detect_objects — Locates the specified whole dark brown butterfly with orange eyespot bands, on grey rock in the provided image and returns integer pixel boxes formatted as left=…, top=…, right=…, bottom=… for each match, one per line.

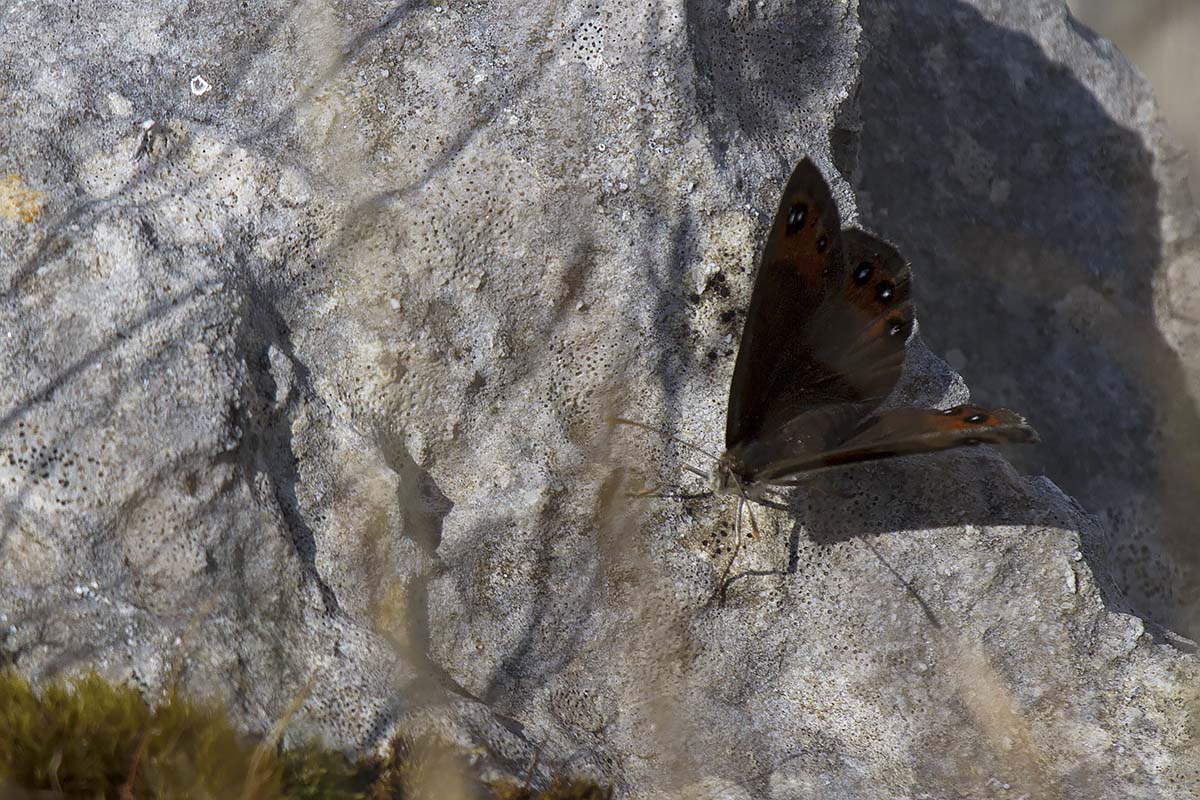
left=613, top=158, right=1038, bottom=524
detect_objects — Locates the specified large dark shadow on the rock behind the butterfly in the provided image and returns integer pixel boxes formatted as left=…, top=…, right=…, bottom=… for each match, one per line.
left=840, top=0, right=1200, bottom=634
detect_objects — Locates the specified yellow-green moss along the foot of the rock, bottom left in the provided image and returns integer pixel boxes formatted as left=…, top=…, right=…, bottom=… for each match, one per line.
left=0, top=669, right=612, bottom=800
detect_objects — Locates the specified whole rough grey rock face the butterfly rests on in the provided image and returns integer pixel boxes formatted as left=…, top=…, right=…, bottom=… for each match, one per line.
left=0, top=0, right=1200, bottom=798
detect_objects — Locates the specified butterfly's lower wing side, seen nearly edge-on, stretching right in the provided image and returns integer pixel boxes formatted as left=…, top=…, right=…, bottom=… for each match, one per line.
left=755, top=405, right=1038, bottom=485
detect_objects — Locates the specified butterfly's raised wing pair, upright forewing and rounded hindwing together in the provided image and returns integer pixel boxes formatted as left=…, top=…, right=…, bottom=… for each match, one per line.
left=725, top=158, right=913, bottom=453
